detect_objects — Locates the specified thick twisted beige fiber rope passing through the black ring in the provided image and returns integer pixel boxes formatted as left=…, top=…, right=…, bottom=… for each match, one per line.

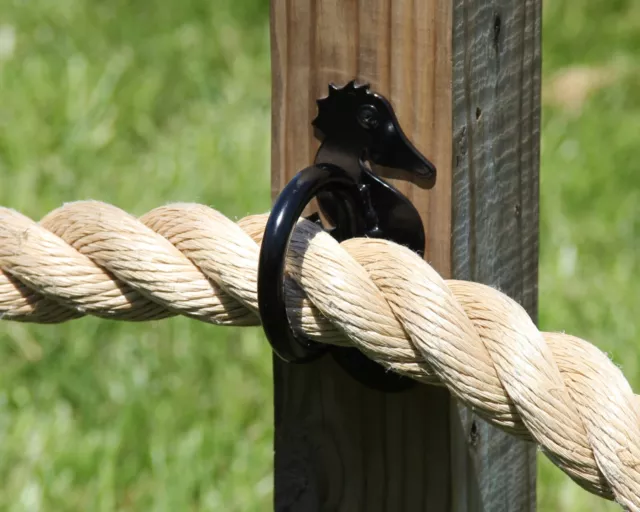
left=0, top=202, right=640, bottom=510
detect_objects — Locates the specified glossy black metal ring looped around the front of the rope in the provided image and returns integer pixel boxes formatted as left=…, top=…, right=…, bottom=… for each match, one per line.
left=258, top=164, right=363, bottom=363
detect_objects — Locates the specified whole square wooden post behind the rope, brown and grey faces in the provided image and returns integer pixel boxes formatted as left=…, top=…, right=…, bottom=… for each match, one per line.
left=271, top=0, right=541, bottom=512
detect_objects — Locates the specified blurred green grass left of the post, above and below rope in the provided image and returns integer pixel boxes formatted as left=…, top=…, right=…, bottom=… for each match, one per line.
left=0, top=0, right=273, bottom=512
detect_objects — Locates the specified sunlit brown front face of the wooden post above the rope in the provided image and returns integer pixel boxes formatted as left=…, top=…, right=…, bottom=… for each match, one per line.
left=271, top=0, right=452, bottom=266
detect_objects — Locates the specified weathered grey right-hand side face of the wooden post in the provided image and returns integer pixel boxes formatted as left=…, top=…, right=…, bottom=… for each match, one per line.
left=452, top=0, right=541, bottom=511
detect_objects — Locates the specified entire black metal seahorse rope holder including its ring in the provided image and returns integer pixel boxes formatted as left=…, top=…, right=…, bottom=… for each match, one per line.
left=258, top=82, right=436, bottom=391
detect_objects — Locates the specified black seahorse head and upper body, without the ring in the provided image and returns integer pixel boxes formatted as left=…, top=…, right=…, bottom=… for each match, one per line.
left=313, top=81, right=436, bottom=253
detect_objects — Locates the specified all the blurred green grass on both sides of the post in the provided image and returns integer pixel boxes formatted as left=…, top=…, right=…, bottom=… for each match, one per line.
left=0, top=0, right=640, bottom=512
